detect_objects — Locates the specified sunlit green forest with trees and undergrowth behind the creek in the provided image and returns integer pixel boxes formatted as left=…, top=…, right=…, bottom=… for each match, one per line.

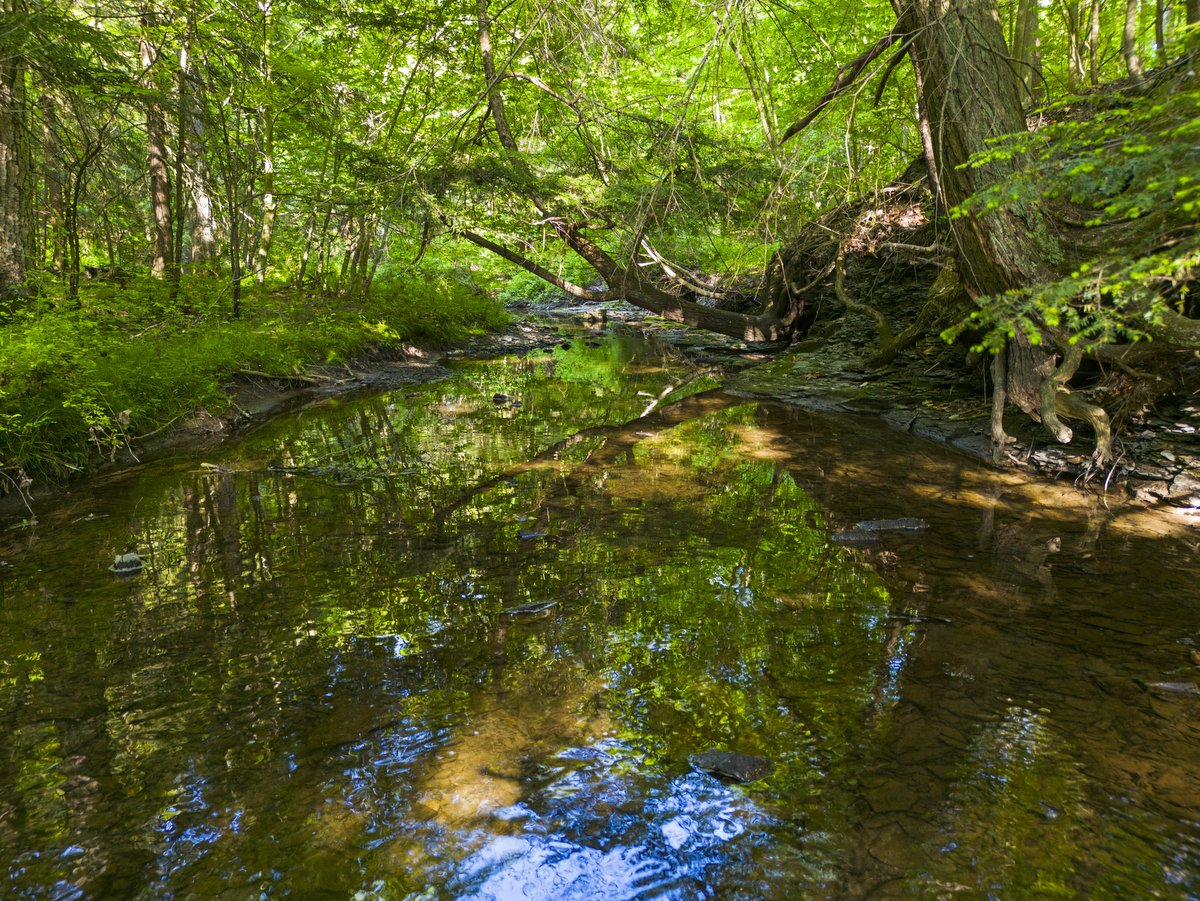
left=0, top=0, right=1200, bottom=488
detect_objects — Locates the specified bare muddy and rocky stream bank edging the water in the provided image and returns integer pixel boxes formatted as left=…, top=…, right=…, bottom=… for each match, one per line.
left=0, top=301, right=1200, bottom=521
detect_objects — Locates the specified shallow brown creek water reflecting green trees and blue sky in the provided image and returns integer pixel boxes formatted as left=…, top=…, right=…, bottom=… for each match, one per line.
left=0, top=334, right=1200, bottom=900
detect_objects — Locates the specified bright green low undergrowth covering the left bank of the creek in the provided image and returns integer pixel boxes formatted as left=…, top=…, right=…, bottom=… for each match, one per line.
left=0, top=278, right=508, bottom=493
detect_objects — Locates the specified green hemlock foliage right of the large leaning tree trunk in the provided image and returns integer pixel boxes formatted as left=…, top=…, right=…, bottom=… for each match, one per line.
left=948, top=62, right=1200, bottom=349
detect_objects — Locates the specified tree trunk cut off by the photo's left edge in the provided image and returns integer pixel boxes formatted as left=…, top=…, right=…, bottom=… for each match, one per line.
left=0, top=0, right=30, bottom=302
